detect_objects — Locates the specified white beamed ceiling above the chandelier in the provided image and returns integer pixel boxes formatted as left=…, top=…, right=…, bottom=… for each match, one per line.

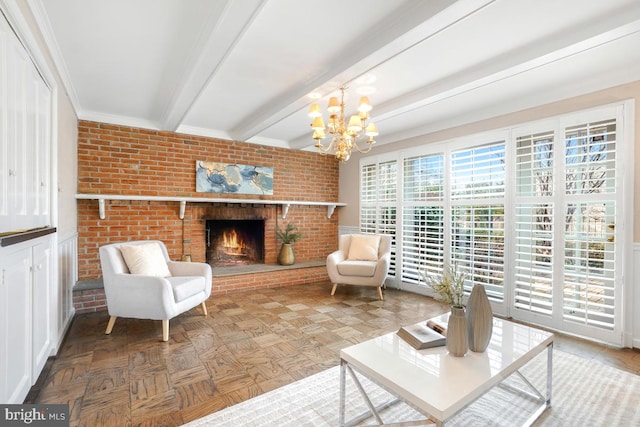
left=28, top=0, right=640, bottom=149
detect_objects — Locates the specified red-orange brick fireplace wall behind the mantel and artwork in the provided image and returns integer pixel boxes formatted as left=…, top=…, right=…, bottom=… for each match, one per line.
left=78, top=121, right=339, bottom=310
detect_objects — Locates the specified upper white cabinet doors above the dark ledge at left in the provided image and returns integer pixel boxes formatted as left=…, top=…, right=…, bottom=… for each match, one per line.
left=0, top=10, right=52, bottom=236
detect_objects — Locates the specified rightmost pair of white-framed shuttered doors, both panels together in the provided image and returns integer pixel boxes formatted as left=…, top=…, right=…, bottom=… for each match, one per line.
left=511, top=107, right=631, bottom=344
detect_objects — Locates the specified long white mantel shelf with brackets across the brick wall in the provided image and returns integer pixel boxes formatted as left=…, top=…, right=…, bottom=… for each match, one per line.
left=76, top=194, right=346, bottom=219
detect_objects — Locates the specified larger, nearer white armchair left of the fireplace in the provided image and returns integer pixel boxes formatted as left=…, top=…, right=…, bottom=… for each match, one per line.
left=100, top=240, right=212, bottom=341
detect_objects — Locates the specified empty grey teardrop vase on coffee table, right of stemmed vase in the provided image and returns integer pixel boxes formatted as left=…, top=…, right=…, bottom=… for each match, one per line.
left=467, top=285, right=493, bottom=352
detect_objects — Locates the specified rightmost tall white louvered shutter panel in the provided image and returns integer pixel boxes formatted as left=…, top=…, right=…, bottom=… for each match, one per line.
left=563, top=119, right=616, bottom=330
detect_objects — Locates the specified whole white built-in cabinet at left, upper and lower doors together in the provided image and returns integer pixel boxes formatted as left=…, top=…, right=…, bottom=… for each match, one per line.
left=0, top=8, right=60, bottom=404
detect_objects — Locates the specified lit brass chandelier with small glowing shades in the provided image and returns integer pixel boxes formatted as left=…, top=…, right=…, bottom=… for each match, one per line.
left=309, top=86, right=378, bottom=163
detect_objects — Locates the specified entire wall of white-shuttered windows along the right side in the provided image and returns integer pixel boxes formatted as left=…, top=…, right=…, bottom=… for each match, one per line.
left=360, top=103, right=633, bottom=344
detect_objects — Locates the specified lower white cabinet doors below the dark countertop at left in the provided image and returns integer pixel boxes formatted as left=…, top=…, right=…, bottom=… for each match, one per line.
left=0, top=237, right=52, bottom=403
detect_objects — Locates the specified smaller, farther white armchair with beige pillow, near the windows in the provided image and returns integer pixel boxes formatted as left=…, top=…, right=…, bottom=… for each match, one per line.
left=327, top=234, right=391, bottom=300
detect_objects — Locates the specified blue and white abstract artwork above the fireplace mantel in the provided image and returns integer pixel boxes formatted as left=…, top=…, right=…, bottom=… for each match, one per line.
left=196, top=160, right=273, bottom=196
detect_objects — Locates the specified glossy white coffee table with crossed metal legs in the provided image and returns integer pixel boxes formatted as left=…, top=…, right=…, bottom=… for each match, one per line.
left=339, top=318, right=553, bottom=426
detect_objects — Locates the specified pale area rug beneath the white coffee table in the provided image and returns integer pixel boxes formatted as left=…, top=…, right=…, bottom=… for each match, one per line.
left=185, top=350, right=640, bottom=427
